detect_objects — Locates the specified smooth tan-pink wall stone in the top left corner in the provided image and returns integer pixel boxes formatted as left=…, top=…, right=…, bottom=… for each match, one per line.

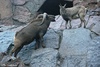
left=0, top=0, right=12, bottom=19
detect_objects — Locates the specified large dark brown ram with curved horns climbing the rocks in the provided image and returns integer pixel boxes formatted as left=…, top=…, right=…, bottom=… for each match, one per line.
left=10, top=13, right=55, bottom=57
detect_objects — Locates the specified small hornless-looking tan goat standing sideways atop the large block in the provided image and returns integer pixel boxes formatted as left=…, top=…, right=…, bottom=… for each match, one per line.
left=59, top=4, right=87, bottom=29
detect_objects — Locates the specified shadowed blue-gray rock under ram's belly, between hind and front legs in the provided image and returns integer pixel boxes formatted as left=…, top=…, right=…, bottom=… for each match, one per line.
left=18, top=41, right=36, bottom=65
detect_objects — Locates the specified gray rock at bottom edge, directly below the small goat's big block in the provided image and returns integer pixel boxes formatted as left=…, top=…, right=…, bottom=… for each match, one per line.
left=60, top=55, right=86, bottom=67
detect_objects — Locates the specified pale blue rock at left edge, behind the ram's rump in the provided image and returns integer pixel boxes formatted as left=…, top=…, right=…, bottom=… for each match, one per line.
left=0, top=31, right=15, bottom=52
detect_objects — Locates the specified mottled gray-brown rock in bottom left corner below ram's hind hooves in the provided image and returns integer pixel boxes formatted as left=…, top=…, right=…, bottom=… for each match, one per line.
left=0, top=55, right=26, bottom=67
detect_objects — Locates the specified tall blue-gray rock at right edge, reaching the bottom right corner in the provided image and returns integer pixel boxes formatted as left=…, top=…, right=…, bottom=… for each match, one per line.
left=87, top=36, right=100, bottom=67
